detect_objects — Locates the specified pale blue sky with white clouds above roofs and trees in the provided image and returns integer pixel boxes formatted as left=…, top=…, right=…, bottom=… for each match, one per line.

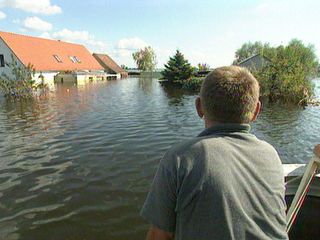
left=0, top=0, right=320, bottom=68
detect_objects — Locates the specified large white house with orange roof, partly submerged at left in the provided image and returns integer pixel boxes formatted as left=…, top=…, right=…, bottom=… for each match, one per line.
left=0, top=32, right=107, bottom=84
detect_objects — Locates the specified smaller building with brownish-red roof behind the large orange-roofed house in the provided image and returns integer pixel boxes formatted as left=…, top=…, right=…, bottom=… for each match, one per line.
left=93, top=53, right=128, bottom=79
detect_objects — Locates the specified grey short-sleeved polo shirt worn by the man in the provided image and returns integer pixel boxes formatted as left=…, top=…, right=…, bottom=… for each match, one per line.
left=141, top=124, right=288, bottom=240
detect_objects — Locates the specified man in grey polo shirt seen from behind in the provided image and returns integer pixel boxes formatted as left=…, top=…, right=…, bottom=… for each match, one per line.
left=141, top=66, right=288, bottom=240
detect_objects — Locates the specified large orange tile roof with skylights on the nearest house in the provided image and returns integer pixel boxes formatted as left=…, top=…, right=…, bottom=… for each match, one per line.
left=0, top=31, right=103, bottom=71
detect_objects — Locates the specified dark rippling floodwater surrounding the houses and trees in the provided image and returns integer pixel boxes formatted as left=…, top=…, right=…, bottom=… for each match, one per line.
left=0, top=79, right=320, bottom=240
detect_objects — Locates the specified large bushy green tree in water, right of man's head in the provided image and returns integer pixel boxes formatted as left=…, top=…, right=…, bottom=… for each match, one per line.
left=239, top=39, right=319, bottom=103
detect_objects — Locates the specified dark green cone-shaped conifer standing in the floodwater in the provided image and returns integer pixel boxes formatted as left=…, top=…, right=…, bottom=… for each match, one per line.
left=162, top=50, right=193, bottom=82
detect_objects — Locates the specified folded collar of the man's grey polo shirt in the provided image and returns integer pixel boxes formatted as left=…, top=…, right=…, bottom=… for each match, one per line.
left=198, top=123, right=251, bottom=137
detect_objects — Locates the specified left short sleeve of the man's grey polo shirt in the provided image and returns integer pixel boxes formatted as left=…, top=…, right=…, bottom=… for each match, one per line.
left=140, top=153, right=176, bottom=233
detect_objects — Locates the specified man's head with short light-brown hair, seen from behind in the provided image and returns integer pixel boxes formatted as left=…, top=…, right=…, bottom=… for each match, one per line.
left=196, top=66, right=261, bottom=123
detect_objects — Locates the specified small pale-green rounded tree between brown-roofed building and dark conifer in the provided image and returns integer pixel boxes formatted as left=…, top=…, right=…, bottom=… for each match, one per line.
left=132, top=46, right=157, bottom=71
